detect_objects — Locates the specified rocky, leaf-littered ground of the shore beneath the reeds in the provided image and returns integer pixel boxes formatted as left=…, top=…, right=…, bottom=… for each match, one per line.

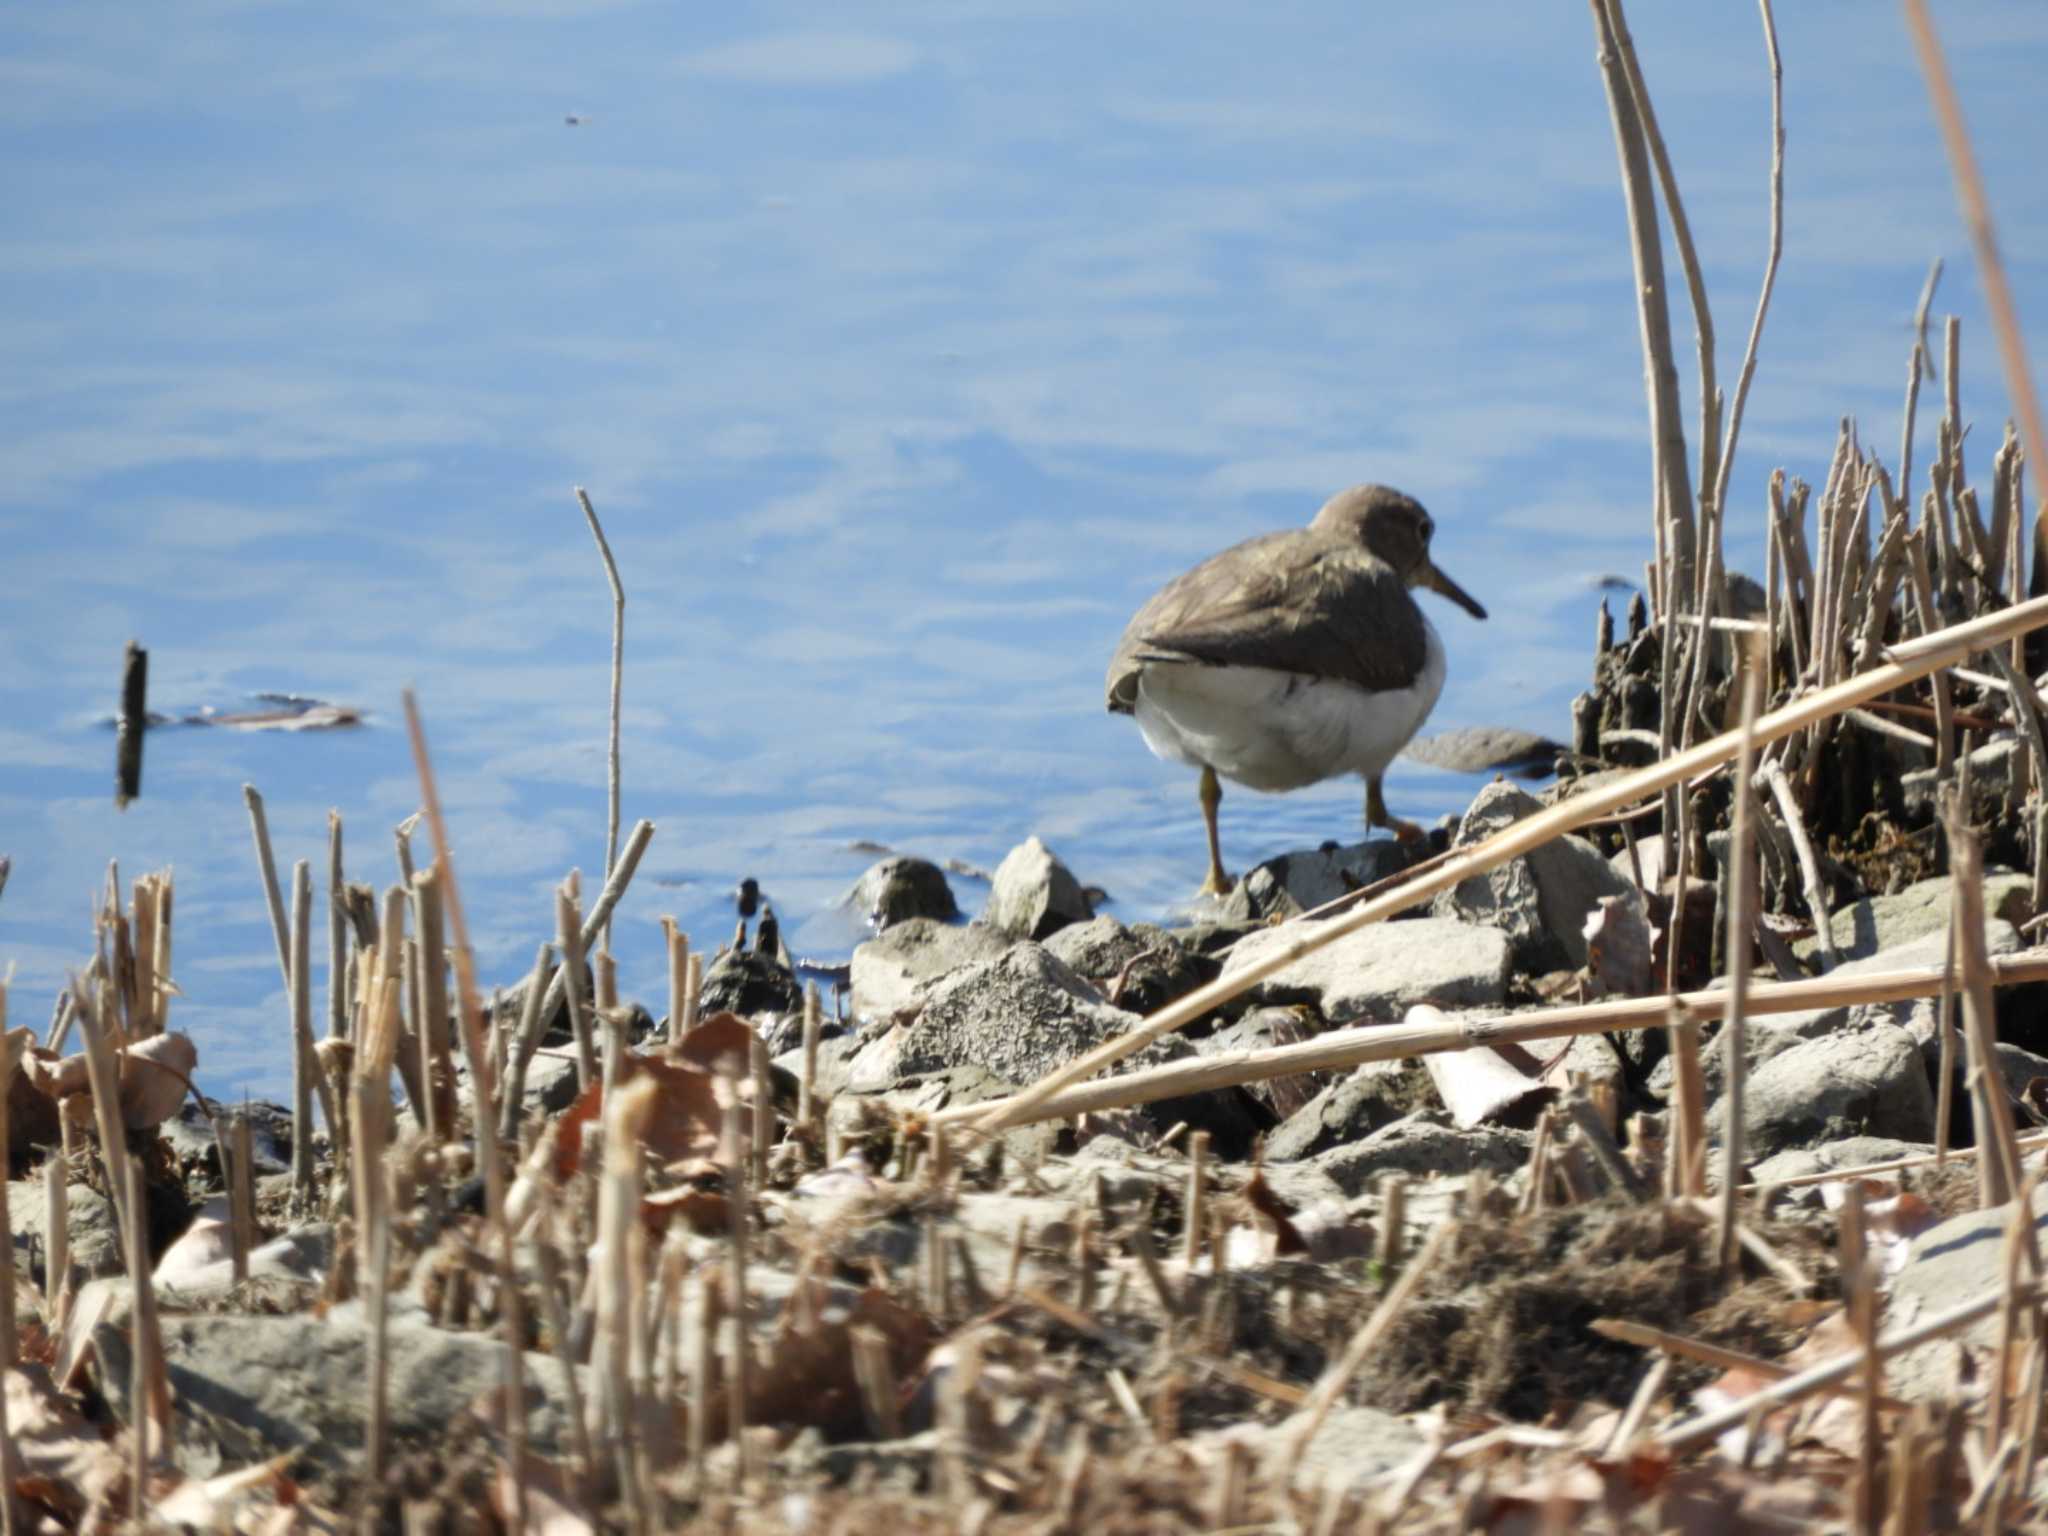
left=8, top=761, right=2048, bottom=1530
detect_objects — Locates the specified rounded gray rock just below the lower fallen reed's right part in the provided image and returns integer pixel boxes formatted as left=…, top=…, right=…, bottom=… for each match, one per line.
left=1710, top=1024, right=1933, bottom=1159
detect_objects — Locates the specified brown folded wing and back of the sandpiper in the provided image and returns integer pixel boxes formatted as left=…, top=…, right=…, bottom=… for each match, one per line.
left=1108, top=530, right=1427, bottom=713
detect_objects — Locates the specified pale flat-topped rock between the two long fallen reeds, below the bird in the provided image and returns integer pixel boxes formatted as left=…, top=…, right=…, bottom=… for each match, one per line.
left=1223, top=918, right=1511, bottom=1024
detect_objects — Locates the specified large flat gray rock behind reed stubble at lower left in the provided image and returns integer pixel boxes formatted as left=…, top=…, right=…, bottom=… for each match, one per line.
left=92, top=1313, right=590, bottom=1477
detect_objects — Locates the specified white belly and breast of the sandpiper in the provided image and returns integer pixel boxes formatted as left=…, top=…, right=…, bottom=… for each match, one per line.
left=1135, top=627, right=1444, bottom=791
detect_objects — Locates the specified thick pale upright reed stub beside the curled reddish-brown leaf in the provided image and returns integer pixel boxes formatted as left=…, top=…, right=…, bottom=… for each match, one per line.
left=592, top=1075, right=655, bottom=1530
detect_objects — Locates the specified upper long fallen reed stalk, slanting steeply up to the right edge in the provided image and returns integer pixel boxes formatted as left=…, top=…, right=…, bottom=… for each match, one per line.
left=966, top=598, right=2048, bottom=1130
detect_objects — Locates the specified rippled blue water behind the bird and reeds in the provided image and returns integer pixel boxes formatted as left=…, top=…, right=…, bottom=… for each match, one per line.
left=0, top=0, right=2048, bottom=1096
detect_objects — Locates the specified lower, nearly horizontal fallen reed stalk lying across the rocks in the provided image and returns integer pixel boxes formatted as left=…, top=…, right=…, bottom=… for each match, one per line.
left=950, top=952, right=2048, bottom=1124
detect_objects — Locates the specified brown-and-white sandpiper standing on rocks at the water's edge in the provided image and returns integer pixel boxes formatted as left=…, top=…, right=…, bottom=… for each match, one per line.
left=1106, top=485, right=1487, bottom=895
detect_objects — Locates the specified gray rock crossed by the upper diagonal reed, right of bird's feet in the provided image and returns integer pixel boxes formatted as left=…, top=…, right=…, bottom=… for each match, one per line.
left=1432, top=782, right=1640, bottom=973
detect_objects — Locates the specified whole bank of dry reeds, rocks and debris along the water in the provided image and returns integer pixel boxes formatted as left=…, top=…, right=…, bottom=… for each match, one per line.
left=0, top=0, right=2048, bottom=1536
